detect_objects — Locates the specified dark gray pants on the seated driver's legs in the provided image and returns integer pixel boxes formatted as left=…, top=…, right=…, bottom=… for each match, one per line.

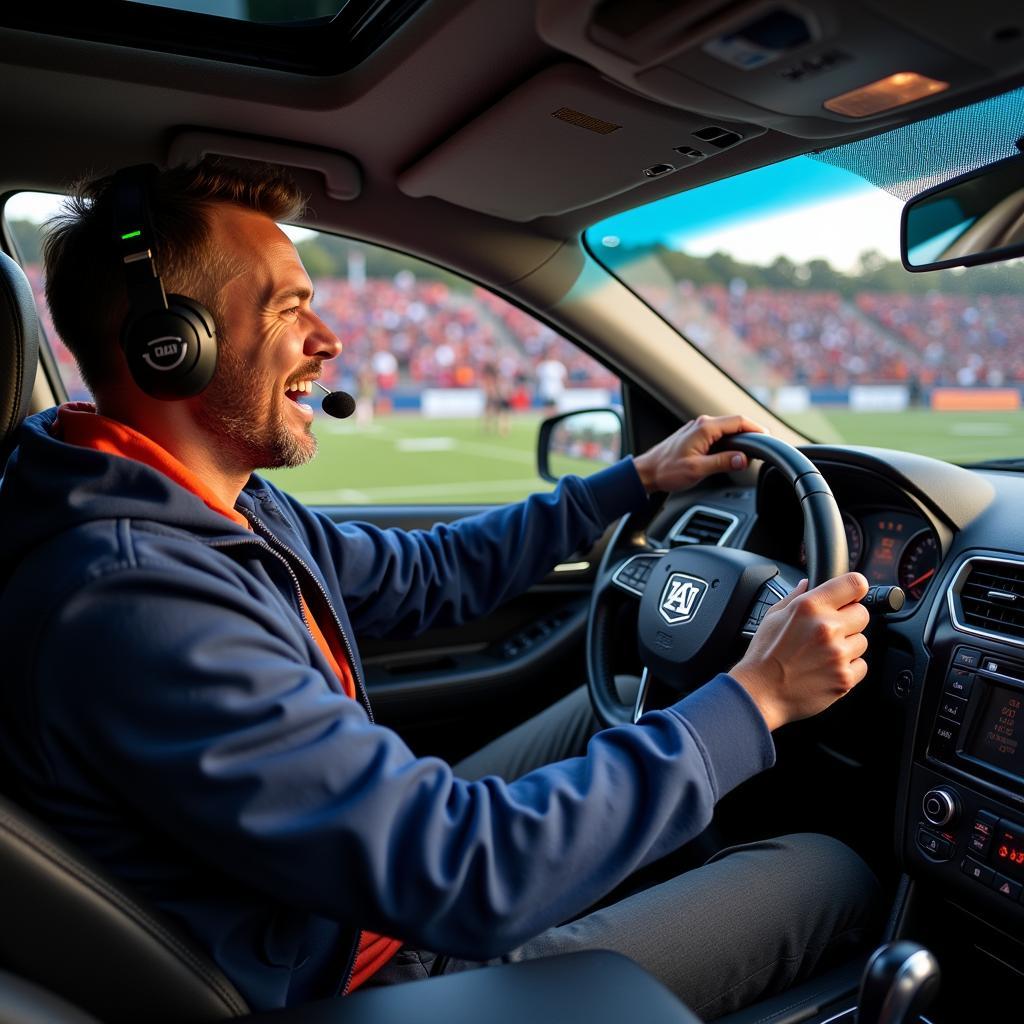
left=367, top=689, right=879, bottom=1020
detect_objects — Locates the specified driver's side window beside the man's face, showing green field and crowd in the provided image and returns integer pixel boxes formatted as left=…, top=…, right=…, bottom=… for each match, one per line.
left=5, top=193, right=620, bottom=505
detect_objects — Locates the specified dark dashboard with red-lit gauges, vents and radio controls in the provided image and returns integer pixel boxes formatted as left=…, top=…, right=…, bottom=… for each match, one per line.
left=651, top=445, right=1024, bottom=1003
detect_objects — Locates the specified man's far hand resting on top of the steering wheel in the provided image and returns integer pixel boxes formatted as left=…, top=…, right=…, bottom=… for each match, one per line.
left=634, top=416, right=766, bottom=494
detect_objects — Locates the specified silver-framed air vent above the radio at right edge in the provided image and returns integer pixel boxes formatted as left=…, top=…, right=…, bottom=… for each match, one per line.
left=949, top=558, right=1024, bottom=646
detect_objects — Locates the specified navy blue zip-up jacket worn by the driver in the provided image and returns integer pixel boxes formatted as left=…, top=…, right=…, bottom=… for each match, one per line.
left=0, top=410, right=774, bottom=1010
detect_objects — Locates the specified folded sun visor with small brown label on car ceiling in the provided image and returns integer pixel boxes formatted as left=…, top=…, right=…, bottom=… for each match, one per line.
left=398, top=65, right=765, bottom=221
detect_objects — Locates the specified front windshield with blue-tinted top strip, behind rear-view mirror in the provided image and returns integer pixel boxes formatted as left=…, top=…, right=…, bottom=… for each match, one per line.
left=586, top=90, right=1024, bottom=463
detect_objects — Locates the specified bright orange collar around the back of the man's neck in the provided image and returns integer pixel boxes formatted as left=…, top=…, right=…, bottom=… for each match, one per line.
left=53, top=401, right=251, bottom=529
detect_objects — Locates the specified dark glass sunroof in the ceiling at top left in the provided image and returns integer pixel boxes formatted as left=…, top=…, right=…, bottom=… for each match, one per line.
left=0, top=0, right=429, bottom=75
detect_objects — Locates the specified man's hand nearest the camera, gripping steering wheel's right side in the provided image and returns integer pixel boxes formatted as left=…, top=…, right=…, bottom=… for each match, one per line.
left=732, top=572, right=869, bottom=729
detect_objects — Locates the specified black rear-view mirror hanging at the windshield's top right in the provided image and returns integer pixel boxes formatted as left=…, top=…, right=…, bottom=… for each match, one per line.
left=900, top=155, right=1024, bottom=271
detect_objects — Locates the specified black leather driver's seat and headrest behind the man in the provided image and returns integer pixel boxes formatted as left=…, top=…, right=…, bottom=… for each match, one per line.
left=0, top=253, right=249, bottom=1022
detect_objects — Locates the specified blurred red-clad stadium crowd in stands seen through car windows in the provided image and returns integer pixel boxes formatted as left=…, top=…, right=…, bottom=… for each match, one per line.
left=19, top=264, right=1024, bottom=410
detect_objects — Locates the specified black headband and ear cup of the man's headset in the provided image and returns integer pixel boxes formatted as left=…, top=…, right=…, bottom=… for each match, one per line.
left=113, top=164, right=217, bottom=401
